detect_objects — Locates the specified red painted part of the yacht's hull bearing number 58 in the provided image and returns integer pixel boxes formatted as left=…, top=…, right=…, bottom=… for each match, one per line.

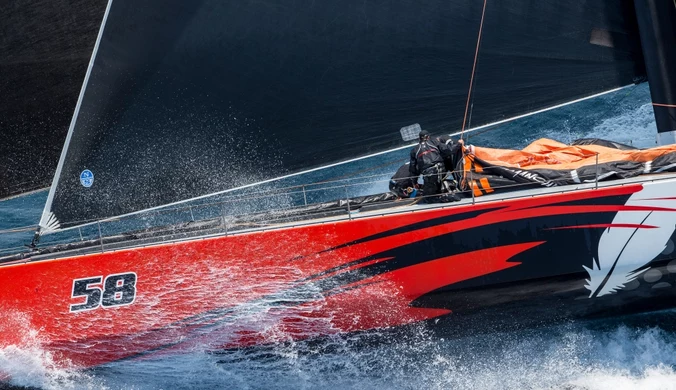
left=0, top=180, right=673, bottom=367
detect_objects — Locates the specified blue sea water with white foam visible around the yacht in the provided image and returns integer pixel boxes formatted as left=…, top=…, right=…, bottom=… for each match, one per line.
left=0, top=85, right=676, bottom=390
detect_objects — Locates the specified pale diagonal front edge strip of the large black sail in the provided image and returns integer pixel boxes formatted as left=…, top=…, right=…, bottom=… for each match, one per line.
left=38, top=0, right=113, bottom=234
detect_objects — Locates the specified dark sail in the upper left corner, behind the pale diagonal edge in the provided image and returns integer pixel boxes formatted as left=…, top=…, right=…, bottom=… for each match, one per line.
left=0, top=0, right=107, bottom=199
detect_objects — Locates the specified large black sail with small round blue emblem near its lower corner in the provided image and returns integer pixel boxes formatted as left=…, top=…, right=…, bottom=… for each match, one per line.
left=40, top=0, right=645, bottom=232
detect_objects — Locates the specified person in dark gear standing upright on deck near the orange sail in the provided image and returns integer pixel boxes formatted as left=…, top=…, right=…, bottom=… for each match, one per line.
left=409, top=130, right=451, bottom=203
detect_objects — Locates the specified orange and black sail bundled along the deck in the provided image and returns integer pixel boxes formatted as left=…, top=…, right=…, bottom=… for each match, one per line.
left=456, top=138, right=676, bottom=196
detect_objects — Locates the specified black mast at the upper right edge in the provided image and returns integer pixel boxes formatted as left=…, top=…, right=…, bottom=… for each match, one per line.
left=634, top=0, right=676, bottom=145
